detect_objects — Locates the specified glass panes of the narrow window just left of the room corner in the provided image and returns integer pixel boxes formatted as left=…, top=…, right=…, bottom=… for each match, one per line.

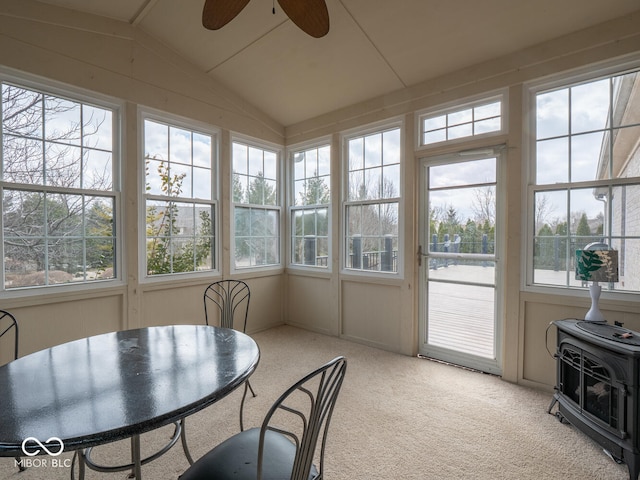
left=231, top=142, right=280, bottom=269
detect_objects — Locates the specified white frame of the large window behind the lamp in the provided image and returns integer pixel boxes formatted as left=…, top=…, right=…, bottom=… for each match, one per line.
left=521, top=57, right=640, bottom=300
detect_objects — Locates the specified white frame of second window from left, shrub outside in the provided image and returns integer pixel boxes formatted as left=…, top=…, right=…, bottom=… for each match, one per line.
left=137, top=106, right=222, bottom=283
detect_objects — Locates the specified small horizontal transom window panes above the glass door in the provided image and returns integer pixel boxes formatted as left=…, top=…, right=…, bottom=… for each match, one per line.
left=420, top=98, right=503, bottom=146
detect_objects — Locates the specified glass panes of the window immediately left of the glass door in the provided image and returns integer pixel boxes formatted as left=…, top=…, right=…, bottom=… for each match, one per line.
left=344, top=128, right=401, bottom=273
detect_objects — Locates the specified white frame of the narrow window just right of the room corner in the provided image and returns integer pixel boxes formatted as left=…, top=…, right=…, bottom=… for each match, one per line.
left=286, top=137, right=335, bottom=273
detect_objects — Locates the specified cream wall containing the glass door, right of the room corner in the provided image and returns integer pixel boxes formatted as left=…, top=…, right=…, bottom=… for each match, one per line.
left=286, top=11, right=640, bottom=390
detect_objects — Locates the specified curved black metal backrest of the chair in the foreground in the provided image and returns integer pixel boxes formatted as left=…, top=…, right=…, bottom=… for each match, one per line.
left=258, top=356, right=347, bottom=480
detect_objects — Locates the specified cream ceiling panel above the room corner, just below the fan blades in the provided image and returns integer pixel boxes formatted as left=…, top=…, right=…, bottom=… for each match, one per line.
left=211, top=0, right=403, bottom=125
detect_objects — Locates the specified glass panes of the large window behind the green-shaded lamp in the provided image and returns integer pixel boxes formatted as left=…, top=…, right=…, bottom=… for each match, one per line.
left=529, top=67, right=640, bottom=292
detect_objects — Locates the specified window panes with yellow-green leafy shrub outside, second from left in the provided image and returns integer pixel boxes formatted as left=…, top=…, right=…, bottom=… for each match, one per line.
left=143, top=115, right=217, bottom=276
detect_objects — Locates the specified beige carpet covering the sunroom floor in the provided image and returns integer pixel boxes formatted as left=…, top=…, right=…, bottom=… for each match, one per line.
left=0, top=327, right=628, bottom=480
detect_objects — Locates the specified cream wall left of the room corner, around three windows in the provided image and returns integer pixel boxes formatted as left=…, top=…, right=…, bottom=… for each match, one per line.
left=0, top=0, right=284, bottom=361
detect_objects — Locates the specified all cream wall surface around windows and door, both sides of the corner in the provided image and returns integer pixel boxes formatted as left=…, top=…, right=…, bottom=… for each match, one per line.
left=0, top=0, right=640, bottom=388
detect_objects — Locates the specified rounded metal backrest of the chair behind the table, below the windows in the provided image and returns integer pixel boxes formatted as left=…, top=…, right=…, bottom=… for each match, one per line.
left=204, top=280, right=251, bottom=332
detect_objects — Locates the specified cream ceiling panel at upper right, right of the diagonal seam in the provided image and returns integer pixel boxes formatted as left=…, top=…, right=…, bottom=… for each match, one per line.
left=344, top=0, right=640, bottom=86
